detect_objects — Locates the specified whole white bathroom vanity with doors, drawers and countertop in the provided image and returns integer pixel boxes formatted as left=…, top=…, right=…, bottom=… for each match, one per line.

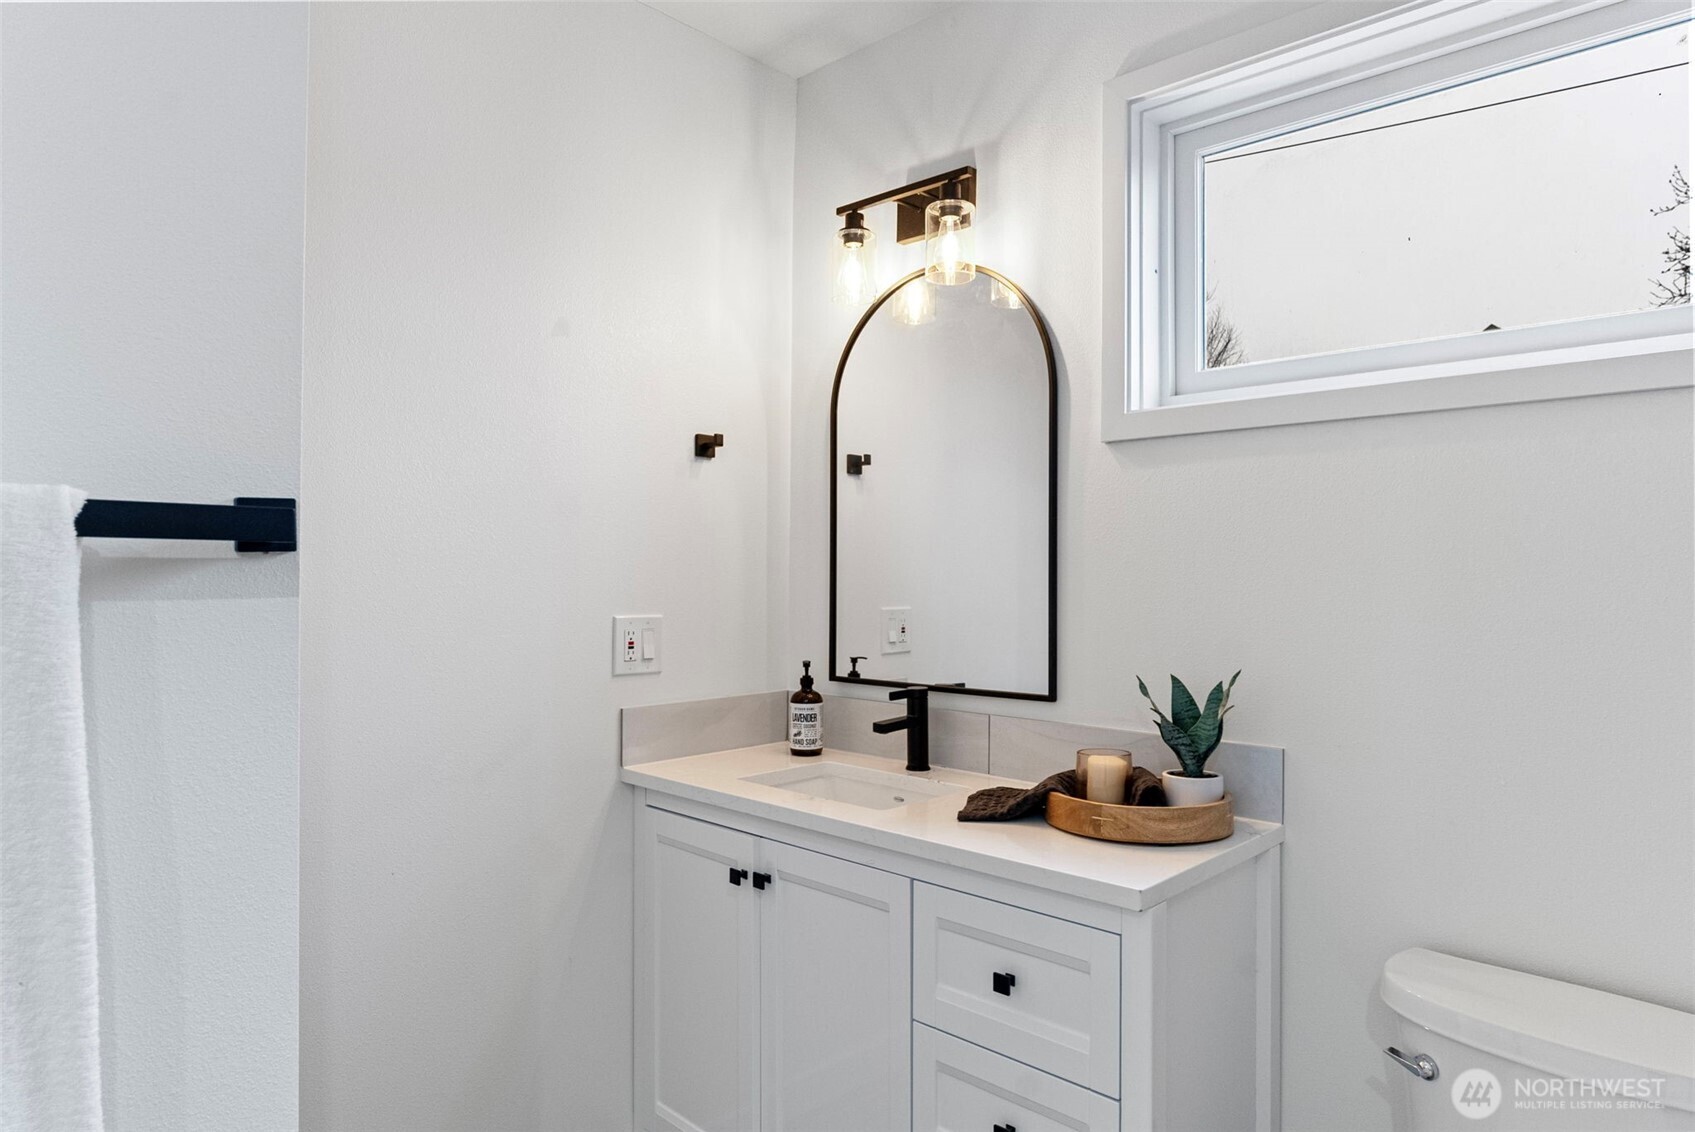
left=625, top=749, right=1281, bottom=1132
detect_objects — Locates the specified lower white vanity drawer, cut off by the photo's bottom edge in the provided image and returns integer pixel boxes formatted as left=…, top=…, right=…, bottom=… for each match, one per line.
left=912, top=1022, right=1119, bottom=1132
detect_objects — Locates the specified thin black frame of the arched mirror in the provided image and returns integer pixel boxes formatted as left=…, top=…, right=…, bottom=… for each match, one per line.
left=829, top=264, right=1059, bottom=702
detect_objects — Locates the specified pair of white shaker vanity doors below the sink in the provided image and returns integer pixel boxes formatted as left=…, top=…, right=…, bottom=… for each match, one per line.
left=636, top=808, right=912, bottom=1132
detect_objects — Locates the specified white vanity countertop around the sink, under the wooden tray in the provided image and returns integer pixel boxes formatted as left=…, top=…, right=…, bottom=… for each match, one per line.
left=622, top=742, right=1283, bottom=910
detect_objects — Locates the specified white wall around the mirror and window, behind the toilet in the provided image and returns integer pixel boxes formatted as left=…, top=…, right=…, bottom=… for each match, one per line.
left=790, top=3, right=1695, bottom=1132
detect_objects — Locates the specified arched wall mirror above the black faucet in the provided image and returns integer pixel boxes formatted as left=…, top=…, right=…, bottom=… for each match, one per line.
left=831, top=266, right=1059, bottom=700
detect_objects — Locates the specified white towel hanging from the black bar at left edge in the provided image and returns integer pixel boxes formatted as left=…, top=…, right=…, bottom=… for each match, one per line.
left=0, top=483, right=102, bottom=1132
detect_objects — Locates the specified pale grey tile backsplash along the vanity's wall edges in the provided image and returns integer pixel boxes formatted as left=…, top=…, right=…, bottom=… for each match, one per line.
left=620, top=691, right=1283, bottom=822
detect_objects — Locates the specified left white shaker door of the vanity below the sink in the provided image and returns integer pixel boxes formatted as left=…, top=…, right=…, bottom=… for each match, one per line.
left=636, top=808, right=761, bottom=1132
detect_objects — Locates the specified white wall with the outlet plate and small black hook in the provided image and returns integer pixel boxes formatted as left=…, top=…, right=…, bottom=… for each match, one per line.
left=302, top=3, right=796, bottom=1132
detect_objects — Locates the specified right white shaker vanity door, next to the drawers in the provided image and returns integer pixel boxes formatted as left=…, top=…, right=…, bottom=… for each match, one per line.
left=758, top=841, right=908, bottom=1132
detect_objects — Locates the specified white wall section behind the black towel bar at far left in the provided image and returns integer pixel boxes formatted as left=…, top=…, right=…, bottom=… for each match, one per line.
left=0, top=3, right=307, bottom=1132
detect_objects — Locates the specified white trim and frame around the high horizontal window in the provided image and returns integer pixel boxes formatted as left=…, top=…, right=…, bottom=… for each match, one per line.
left=1102, top=0, right=1695, bottom=441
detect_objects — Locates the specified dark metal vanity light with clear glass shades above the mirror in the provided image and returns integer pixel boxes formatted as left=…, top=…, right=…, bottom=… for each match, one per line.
left=834, top=164, right=976, bottom=306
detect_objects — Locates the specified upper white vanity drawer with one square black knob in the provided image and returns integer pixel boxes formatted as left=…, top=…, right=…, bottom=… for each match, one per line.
left=912, top=881, right=1120, bottom=1096
